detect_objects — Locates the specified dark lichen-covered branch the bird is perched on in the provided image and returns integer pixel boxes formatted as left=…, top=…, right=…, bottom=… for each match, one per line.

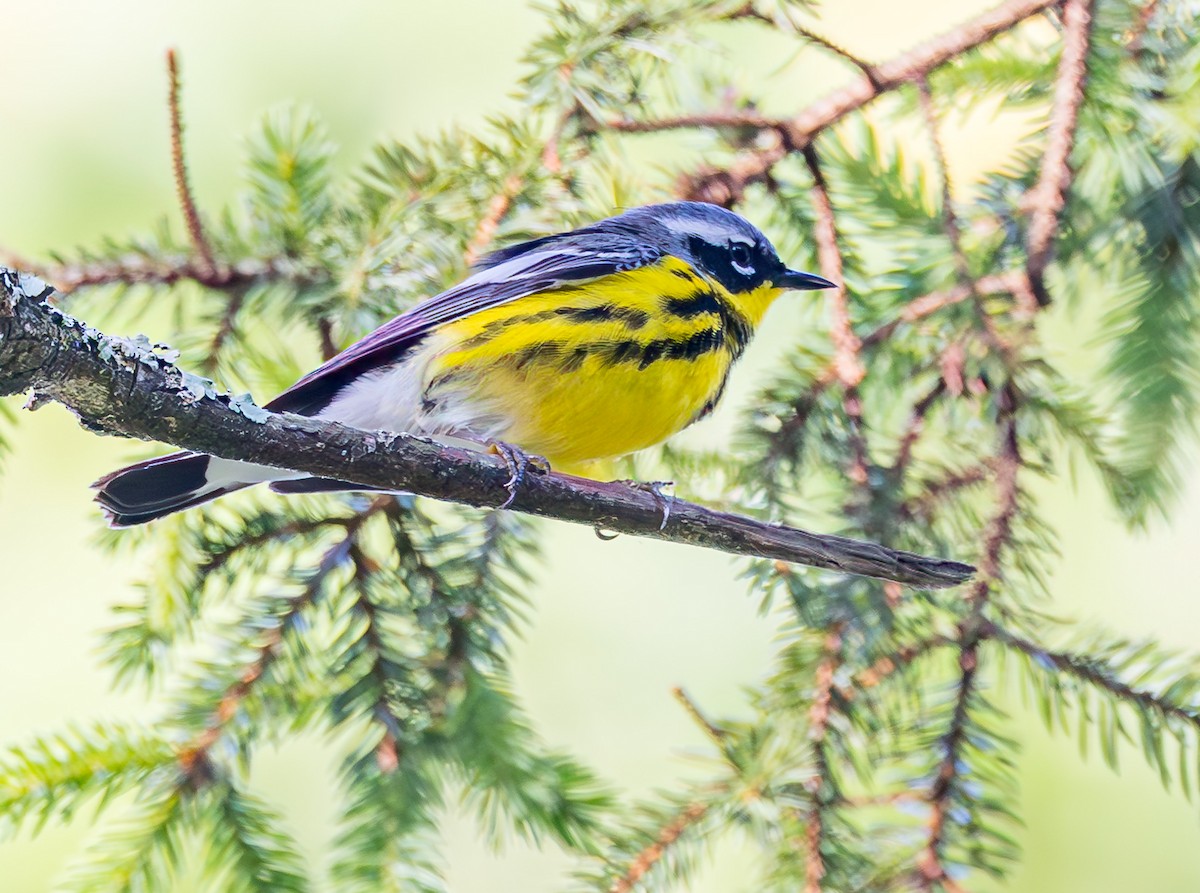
left=0, top=271, right=974, bottom=588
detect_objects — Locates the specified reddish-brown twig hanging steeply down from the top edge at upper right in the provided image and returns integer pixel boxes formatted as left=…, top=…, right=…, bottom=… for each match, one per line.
left=1026, top=0, right=1093, bottom=306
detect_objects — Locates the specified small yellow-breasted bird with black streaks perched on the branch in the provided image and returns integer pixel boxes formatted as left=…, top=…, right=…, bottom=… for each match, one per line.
left=92, top=202, right=835, bottom=527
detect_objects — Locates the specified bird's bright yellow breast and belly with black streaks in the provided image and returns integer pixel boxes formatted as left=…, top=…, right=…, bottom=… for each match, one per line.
left=424, top=258, right=780, bottom=468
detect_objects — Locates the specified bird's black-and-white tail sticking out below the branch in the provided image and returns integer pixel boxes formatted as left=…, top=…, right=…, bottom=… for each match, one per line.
left=92, top=453, right=278, bottom=527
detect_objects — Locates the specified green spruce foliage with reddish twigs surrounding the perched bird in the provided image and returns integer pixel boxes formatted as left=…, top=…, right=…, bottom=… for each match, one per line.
left=0, top=0, right=1200, bottom=893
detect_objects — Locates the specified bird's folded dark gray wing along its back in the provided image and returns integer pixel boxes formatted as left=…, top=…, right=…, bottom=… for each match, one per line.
left=266, top=234, right=661, bottom=415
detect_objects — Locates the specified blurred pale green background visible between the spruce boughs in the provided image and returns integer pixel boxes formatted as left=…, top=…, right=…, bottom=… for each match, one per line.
left=0, top=0, right=1200, bottom=893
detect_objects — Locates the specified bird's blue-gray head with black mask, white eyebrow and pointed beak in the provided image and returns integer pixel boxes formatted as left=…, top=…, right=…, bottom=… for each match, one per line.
left=588, top=202, right=835, bottom=294
